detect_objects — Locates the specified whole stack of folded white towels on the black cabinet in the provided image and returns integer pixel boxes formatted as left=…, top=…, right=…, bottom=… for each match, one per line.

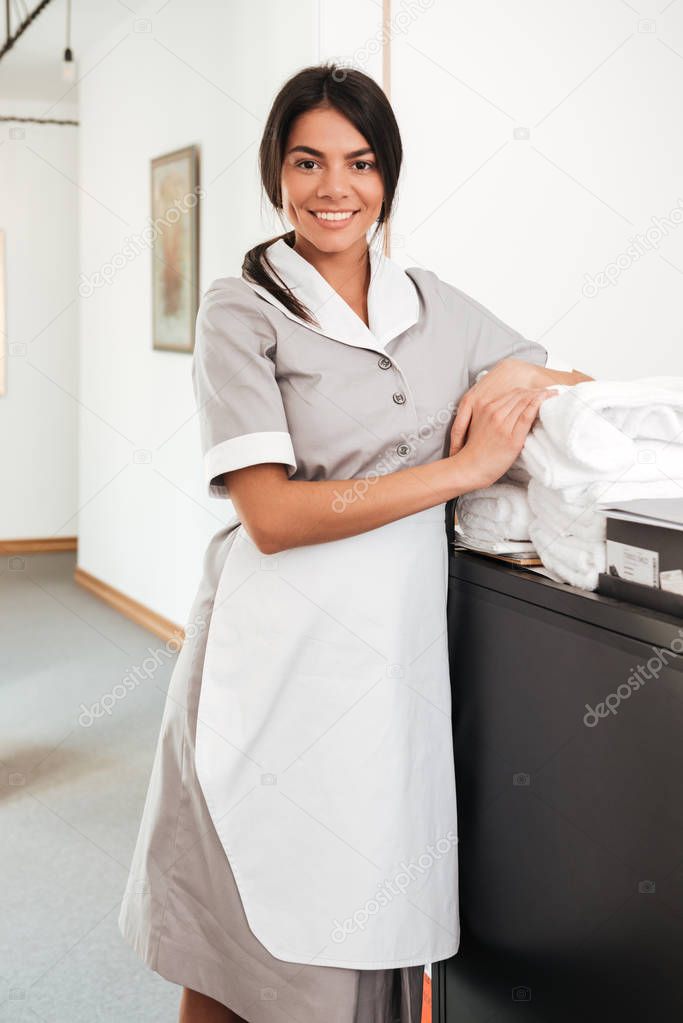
left=456, top=376, right=683, bottom=589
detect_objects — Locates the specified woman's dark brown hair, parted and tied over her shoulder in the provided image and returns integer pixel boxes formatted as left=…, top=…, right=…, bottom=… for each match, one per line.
left=242, top=62, right=403, bottom=326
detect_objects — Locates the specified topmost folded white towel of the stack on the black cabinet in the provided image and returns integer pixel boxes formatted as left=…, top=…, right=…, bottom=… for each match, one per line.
left=515, top=376, right=683, bottom=494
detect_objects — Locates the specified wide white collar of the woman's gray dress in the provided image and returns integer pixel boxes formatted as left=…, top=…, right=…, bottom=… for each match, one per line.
left=243, top=238, right=419, bottom=349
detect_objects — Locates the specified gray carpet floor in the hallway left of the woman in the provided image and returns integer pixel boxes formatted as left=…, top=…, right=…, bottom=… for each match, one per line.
left=0, top=551, right=180, bottom=1023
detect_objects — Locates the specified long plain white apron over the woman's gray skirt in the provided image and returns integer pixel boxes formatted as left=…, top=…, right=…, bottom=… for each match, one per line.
left=195, top=504, right=459, bottom=969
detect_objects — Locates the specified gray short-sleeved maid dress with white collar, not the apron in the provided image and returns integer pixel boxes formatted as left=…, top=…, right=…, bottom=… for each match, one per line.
left=119, top=242, right=547, bottom=1023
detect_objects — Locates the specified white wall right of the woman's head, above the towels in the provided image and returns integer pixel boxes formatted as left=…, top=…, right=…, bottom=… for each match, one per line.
left=392, top=0, right=683, bottom=380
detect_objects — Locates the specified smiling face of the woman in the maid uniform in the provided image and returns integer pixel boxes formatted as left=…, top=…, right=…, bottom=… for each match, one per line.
left=281, top=108, right=384, bottom=253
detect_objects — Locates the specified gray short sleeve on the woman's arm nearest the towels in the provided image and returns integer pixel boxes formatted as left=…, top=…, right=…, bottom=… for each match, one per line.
left=441, top=281, right=548, bottom=387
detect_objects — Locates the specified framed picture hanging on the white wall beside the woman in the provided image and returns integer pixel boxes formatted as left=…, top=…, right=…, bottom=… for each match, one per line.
left=151, top=145, right=199, bottom=352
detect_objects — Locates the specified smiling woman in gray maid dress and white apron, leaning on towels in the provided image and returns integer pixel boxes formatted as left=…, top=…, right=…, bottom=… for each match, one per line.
left=120, top=64, right=582, bottom=1023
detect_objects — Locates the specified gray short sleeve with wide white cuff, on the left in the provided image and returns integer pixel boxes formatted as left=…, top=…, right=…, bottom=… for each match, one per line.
left=192, top=277, right=297, bottom=498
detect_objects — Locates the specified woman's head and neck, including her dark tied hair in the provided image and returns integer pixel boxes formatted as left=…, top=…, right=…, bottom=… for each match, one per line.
left=242, top=65, right=403, bottom=324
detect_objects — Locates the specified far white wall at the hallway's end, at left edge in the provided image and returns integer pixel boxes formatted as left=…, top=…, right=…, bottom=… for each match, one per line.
left=0, top=99, right=78, bottom=540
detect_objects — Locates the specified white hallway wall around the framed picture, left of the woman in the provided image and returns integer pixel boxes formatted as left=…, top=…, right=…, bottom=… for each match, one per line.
left=79, top=0, right=315, bottom=623
